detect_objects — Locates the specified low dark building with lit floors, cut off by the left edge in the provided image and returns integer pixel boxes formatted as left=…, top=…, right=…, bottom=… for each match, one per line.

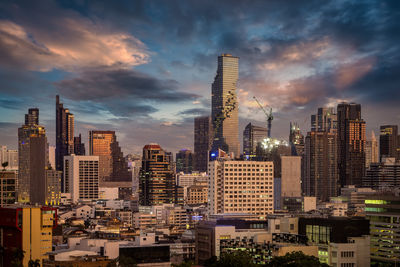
left=0, top=170, right=18, bottom=207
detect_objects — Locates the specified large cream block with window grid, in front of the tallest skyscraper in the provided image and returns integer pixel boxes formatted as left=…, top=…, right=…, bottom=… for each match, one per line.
left=208, top=159, right=274, bottom=218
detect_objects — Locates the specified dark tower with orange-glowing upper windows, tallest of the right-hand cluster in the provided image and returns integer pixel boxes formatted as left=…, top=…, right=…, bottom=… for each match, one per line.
left=337, top=103, right=366, bottom=187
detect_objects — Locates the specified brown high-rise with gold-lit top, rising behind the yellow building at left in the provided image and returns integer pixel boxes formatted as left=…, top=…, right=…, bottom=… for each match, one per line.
left=18, top=109, right=48, bottom=204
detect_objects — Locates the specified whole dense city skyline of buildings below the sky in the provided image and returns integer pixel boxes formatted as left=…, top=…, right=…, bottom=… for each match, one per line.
left=0, top=54, right=400, bottom=267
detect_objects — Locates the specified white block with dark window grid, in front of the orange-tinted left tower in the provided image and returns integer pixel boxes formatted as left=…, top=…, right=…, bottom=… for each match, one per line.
left=64, top=154, right=100, bottom=203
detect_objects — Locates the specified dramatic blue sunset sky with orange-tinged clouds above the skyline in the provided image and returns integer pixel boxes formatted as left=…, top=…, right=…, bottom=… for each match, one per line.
left=0, top=0, right=400, bottom=153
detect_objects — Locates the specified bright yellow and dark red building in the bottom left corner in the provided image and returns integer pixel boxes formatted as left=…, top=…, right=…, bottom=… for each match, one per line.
left=0, top=207, right=57, bottom=266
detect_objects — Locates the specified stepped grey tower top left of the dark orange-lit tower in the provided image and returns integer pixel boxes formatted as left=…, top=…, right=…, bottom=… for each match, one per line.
left=311, top=108, right=337, bottom=132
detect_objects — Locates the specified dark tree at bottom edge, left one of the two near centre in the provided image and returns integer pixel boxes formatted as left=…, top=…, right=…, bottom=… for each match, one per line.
left=204, top=251, right=257, bottom=267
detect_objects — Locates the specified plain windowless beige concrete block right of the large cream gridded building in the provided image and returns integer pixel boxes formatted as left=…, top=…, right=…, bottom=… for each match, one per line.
left=281, top=156, right=301, bottom=197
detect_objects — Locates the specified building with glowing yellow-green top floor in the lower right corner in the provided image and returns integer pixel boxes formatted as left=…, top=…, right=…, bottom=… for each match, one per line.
left=365, top=192, right=400, bottom=266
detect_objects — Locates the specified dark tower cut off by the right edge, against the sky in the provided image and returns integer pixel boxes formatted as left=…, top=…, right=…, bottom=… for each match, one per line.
left=379, top=125, right=398, bottom=160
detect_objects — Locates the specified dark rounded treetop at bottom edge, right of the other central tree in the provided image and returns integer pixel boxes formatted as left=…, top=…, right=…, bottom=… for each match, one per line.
left=265, top=251, right=329, bottom=267
